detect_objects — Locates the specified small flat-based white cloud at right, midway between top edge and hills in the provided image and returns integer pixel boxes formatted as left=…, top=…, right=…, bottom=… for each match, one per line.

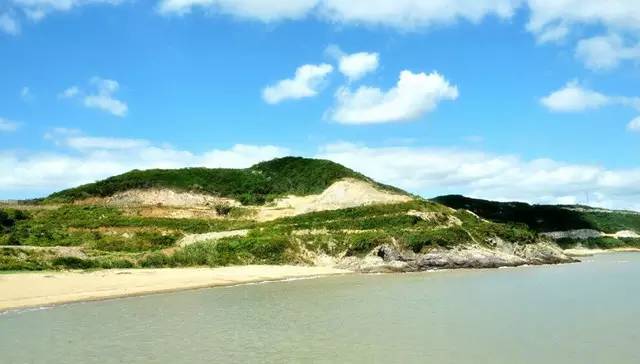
left=540, top=81, right=612, bottom=112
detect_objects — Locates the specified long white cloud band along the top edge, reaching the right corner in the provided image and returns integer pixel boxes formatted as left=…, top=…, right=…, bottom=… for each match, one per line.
left=154, top=0, right=640, bottom=41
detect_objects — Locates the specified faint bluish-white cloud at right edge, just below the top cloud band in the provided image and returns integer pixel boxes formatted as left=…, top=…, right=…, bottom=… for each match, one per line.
left=576, top=34, right=640, bottom=70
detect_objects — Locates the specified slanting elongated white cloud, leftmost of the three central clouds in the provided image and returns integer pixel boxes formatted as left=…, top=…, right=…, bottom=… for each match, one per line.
left=262, top=64, right=333, bottom=104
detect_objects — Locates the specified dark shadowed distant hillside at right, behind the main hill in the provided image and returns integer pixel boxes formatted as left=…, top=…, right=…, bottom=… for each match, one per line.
left=433, top=195, right=640, bottom=233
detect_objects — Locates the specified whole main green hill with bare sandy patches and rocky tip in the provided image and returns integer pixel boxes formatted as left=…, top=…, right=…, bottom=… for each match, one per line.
left=0, top=157, right=572, bottom=272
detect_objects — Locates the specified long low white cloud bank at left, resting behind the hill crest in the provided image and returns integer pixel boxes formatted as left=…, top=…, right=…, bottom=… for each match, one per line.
left=0, top=129, right=288, bottom=198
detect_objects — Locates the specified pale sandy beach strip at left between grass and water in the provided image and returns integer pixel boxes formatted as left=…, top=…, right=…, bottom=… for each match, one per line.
left=0, top=265, right=350, bottom=311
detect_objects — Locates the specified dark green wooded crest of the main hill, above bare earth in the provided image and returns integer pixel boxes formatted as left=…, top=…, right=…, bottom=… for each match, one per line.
left=47, top=157, right=400, bottom=205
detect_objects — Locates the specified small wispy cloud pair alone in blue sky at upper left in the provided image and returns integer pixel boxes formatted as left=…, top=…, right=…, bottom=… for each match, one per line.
left=58, top=77, right=129, bottom=117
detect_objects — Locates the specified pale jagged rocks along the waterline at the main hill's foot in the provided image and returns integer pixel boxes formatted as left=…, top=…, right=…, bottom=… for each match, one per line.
left=334, top=240, right=576, bottom=273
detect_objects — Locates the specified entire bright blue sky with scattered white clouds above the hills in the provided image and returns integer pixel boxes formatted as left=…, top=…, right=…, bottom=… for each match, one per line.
left=0, top=0, right=640, bottom=210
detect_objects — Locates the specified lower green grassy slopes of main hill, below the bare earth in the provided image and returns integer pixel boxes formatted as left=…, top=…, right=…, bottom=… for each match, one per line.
left=0, top=200, right=536, bottom=270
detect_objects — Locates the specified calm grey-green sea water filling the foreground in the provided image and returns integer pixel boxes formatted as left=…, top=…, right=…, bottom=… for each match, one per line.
left=0, top=253, right=640, bottom=364
